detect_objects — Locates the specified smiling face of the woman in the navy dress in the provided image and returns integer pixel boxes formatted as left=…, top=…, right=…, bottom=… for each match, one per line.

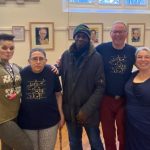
left=135, top=50, right=150, bottom=70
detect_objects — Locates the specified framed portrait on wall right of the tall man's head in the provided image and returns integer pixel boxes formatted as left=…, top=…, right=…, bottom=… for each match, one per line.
left=127, top=23, right=145, bottom=47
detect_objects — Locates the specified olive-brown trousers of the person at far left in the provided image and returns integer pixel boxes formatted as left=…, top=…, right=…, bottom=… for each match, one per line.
left=0, top=121, right=34, bottom=150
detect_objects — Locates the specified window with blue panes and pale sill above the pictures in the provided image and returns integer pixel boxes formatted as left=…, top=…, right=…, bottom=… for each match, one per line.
left=63, top=0, right=150, bottom=14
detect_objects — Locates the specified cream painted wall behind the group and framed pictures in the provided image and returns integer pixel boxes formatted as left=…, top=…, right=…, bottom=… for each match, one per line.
left=0, top=0, right=150, bottom=66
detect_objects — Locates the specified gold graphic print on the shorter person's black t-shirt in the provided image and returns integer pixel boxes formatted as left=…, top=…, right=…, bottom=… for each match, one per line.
left=27, top=79, right=46, bottom=100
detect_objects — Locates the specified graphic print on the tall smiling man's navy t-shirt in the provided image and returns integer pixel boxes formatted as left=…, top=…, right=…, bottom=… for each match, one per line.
left=109, top=55, right=127, bottom=74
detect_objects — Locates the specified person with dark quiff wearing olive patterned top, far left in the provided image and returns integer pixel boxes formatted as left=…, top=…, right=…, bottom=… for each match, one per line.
left=0, top=33, right=33, bottom=150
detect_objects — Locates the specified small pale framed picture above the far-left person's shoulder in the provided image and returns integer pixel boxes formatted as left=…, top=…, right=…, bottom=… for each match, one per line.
left=12, top=26, right=25, bottom=41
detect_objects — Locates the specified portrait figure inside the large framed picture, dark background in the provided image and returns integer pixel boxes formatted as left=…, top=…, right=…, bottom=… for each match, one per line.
left=36, top=27, right=49, bottom=45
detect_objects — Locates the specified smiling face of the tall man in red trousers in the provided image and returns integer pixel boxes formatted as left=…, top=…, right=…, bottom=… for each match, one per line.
left=110, top=23, right=128, bottom=47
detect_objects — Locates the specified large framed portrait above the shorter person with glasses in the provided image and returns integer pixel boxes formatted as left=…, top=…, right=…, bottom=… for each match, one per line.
left=29, top=22, right=54, bottom=50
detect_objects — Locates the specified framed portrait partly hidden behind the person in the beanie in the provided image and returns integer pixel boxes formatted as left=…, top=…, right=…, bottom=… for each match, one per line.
left=86, top=23, right=103, bottom=46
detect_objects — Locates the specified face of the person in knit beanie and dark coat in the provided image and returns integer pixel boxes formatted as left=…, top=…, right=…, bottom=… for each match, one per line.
left=75, top=33, right=90, bottom=49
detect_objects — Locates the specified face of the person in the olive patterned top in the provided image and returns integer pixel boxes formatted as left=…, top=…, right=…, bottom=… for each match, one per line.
left=0, top=40, right=15, bottom=62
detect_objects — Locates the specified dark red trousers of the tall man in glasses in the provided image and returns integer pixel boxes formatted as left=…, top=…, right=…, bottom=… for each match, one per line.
left=100, top=96, right=125, bottom=150
